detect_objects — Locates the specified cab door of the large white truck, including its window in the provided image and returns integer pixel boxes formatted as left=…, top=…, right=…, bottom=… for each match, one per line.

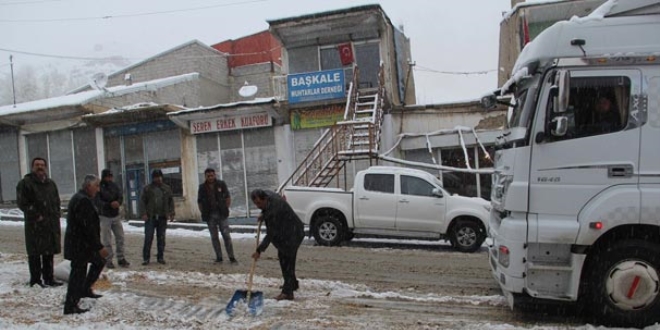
left=529, top=68, right=641, bottom=242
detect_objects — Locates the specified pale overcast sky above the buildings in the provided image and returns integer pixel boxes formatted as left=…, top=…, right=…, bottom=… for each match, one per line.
left=0, top=0, right=537, bottom=104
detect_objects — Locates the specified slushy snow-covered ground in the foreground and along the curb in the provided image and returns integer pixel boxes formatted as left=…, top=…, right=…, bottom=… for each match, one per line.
left=0, top=210, right=660, bottom=330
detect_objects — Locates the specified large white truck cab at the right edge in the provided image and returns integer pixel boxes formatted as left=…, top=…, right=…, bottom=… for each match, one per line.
left=482, top=0, right=660, bottom=327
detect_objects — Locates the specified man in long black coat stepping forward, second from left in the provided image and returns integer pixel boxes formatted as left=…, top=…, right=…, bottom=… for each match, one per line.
left=64, top=174, right=108, bottom=315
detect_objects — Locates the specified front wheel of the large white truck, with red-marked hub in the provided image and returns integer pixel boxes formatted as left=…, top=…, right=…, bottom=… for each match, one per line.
left=586, top=240, right=660, bottom=328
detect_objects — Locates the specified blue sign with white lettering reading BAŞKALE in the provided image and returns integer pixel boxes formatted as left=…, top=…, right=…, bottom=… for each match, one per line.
left=287, top=69, right=346, bottom=104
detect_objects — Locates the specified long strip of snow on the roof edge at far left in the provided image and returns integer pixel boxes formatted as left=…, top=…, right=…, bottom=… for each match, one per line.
left=0, top=72, right=199, bottom=116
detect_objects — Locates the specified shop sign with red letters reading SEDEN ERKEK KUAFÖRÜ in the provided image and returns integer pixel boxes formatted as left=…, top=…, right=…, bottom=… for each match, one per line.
left=190, top=112, right=273, bottom=134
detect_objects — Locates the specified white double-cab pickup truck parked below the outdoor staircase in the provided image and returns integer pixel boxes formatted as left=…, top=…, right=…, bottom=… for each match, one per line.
left=283, top=166, right=490, bottom=252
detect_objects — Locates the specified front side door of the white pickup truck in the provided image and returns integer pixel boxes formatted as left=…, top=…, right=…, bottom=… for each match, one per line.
left=396, top=175, right=446, bottom=233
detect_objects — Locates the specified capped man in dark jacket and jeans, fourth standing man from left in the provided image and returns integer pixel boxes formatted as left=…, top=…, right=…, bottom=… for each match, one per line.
left=140, top=170, right=174, bottom=266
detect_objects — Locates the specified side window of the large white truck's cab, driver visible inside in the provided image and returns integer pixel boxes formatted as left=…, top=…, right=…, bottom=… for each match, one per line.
left=546, top=76, right=631, bottom=140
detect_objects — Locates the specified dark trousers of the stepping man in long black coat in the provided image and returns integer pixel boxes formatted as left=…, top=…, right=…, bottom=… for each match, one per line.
left=64, top=252, right=105, bottom=309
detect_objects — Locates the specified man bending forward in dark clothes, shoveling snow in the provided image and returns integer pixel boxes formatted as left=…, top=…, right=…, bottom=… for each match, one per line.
left=250, top=189, right=305, bottom=300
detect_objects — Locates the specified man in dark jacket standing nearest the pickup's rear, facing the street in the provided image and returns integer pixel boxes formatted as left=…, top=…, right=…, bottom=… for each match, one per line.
left=197, top=168, right=236, bottom=264
